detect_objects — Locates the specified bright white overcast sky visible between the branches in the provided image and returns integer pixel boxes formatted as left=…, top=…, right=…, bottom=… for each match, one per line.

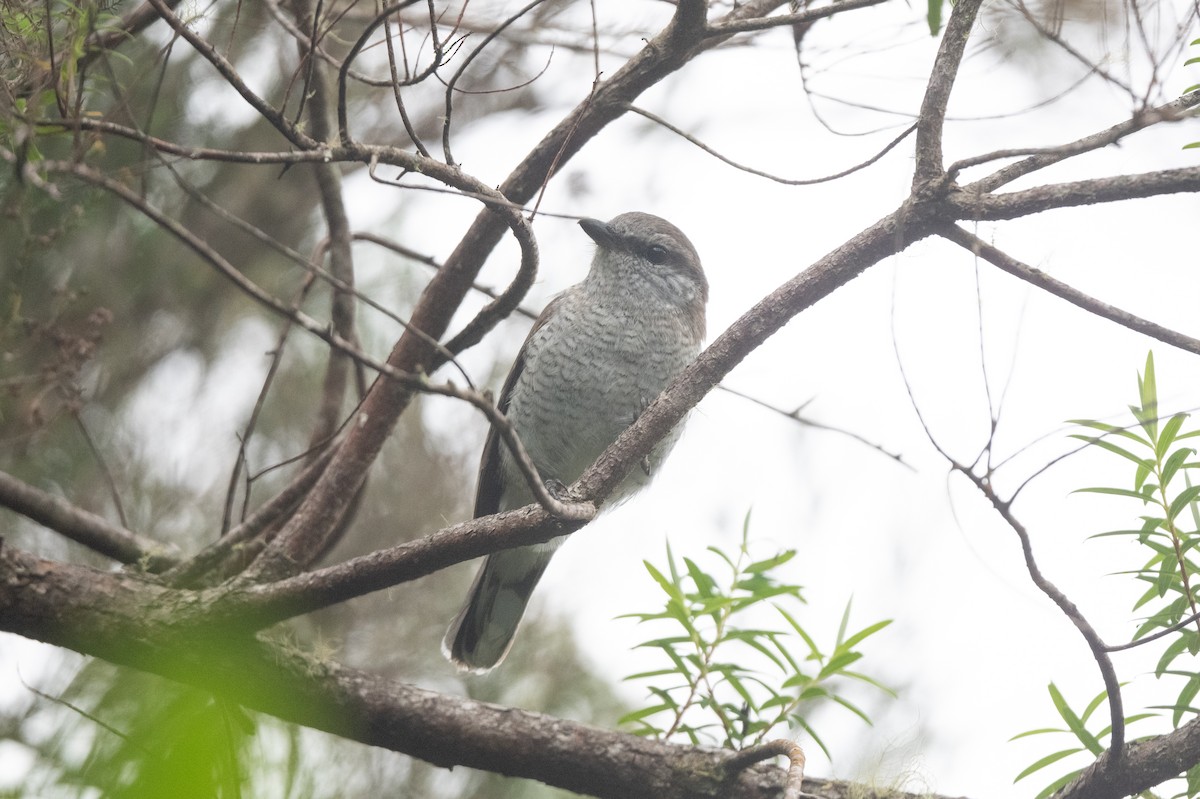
left=0, top=0, right=1200, bottom=799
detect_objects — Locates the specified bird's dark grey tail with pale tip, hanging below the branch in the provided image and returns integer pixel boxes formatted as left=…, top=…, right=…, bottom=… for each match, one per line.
left=442, top=543, right=557, bottom=674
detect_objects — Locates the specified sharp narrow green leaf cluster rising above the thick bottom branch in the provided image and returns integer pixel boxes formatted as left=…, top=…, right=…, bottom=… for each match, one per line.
left=620, top=515, right=890, bottom=756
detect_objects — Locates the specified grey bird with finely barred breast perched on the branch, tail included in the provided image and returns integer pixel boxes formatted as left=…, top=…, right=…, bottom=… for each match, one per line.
left=442, top=212, right=708, bottom=673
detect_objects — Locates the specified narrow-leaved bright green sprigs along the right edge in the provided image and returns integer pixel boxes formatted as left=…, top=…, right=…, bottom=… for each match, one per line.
left=1016, top=353, right=1200, bottom=799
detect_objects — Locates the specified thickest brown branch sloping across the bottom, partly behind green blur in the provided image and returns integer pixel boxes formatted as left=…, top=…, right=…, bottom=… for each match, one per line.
left=0, top=548, right=936, bottom=799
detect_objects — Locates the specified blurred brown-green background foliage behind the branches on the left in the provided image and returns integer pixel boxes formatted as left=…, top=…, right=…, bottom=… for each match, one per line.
left=0, top=0, right=620, bottom=799
